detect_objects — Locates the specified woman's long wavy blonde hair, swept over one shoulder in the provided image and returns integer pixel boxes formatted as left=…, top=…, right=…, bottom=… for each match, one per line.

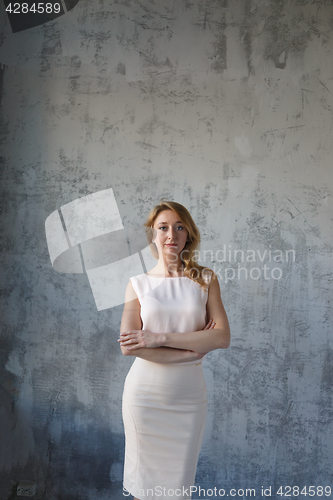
left=144, top=200, right=213, bottom=289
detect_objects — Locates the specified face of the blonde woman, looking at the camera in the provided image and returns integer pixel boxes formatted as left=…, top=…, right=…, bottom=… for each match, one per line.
left=153, top=210, right=188, bottom=260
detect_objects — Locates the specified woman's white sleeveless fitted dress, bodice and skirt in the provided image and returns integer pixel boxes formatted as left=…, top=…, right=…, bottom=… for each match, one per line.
left=123, top=274, right=208, bottom=500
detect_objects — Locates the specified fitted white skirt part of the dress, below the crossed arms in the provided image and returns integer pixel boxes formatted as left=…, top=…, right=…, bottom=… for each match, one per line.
left=123, top=358, right=207, bottom=500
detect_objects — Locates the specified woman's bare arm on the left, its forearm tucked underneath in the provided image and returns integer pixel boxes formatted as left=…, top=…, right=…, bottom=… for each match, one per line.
left=120, top=282, right=203, bottom=363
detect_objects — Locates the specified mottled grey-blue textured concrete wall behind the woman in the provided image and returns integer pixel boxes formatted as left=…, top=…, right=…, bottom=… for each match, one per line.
left=0, top=0, right=333, bottom=500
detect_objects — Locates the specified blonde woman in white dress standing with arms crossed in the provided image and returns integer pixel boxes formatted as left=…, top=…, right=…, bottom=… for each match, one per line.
left=119, top=201, right=230, bottom=500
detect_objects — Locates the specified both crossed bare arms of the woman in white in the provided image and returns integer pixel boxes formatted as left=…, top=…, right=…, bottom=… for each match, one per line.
left=119, top=275, right=230, bottom=363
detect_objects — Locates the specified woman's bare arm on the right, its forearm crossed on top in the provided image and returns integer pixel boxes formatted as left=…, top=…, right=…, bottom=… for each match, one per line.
left=121, top=274, right=230, bottom=354
